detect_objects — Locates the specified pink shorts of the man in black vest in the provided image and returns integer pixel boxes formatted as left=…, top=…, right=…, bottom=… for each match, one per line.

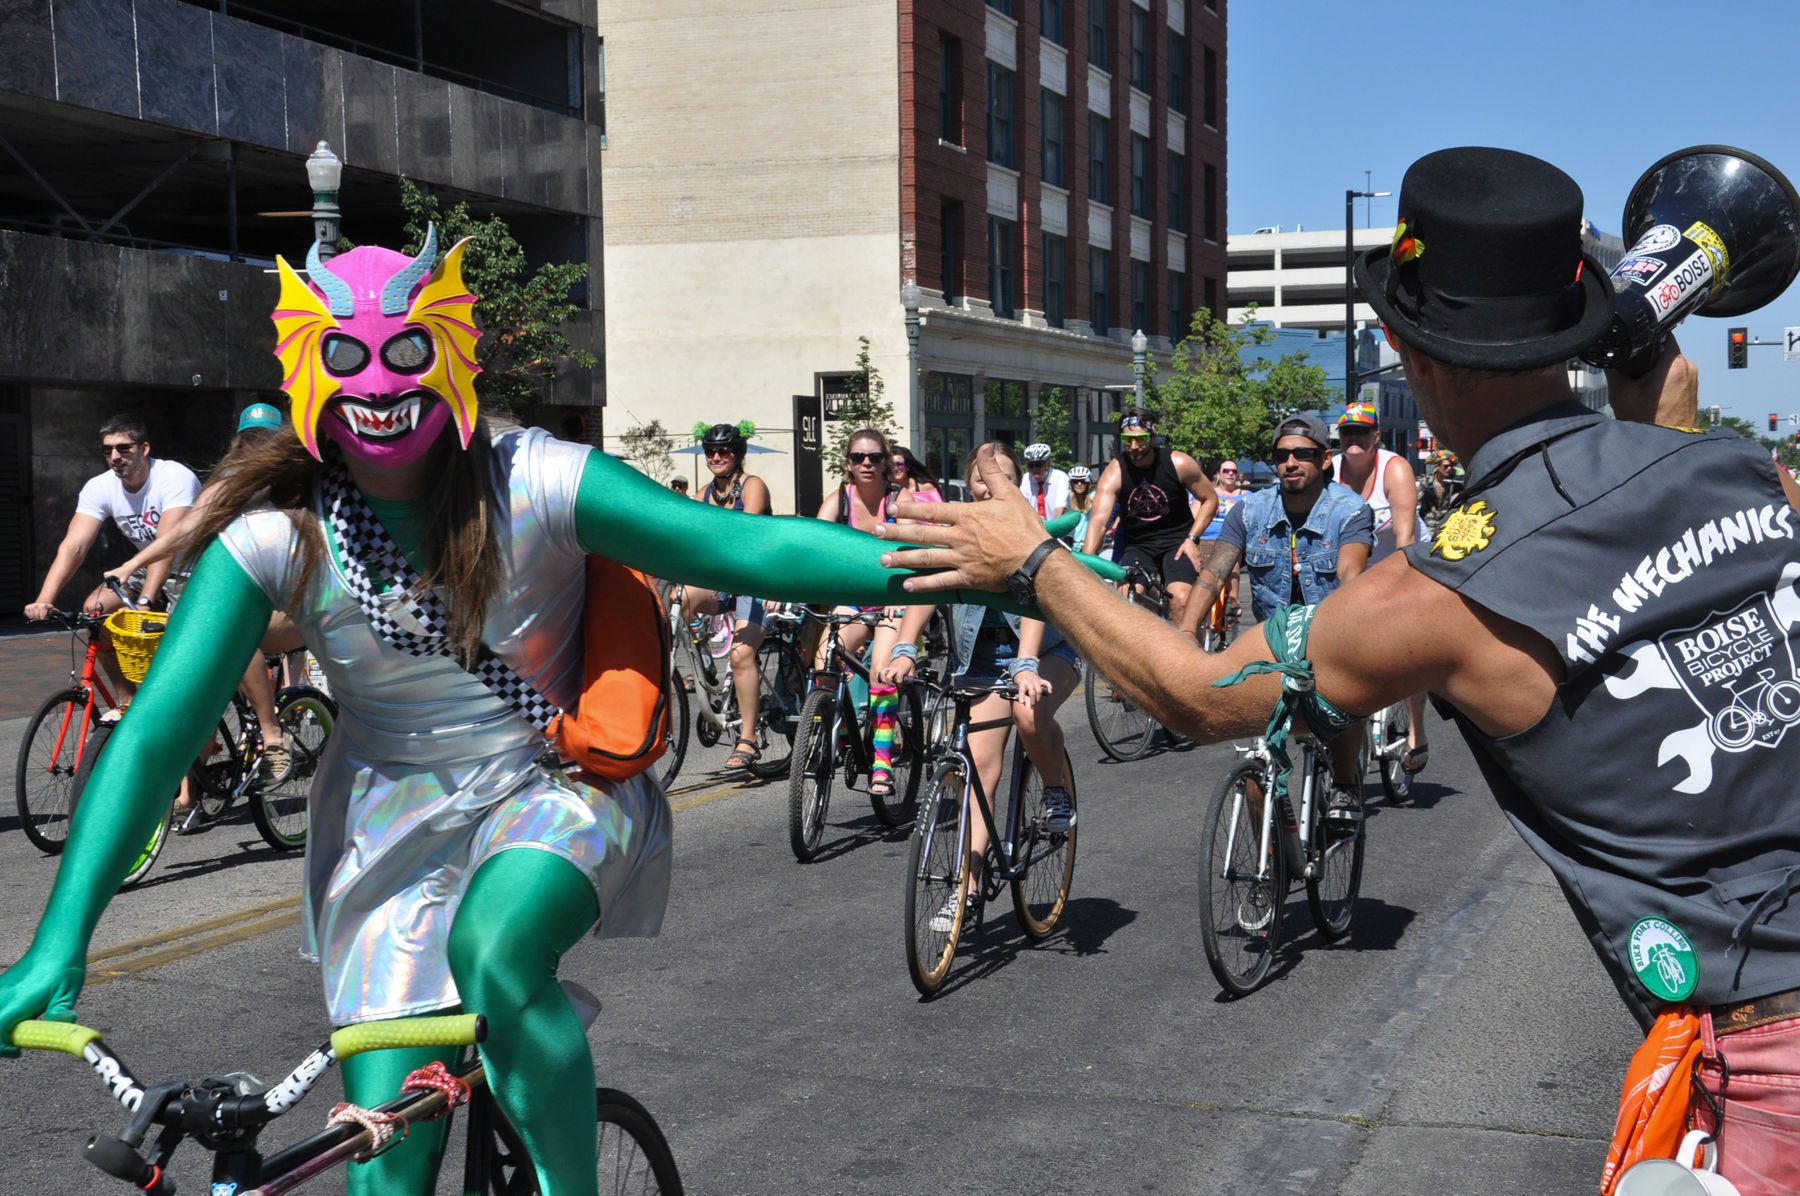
left=1694, top=1014, right=1800, bottom=1196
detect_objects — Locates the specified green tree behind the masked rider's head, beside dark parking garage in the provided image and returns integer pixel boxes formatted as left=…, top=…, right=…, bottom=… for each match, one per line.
left=400, top=177, right=596, bottom=412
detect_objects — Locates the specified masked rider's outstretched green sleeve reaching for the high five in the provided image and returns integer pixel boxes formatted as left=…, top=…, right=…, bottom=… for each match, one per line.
left=576, top=452, right=1111, bottom=614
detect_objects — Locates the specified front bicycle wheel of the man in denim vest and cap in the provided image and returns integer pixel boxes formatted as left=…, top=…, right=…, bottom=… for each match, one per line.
left=1201, top=760, right=1287, bottom=996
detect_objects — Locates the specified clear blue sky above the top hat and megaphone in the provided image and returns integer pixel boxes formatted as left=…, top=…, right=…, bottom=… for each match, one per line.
left=1226, top=0, right=1800, bottom=434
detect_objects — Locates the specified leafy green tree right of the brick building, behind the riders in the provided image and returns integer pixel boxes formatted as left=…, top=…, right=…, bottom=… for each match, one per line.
left=1145, top=304, right=1343, bottom=461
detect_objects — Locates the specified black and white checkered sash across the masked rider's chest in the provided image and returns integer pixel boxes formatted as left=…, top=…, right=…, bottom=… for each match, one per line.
left=324, top=463, right=562, bottom=729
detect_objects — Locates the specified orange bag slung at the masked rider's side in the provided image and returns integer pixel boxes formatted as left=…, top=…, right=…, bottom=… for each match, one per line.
left=547, top=555, right=670, bottom=780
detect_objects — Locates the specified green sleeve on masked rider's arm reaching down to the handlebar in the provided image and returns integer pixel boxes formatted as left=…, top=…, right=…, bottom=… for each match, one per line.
left=32, top=544, right=274, bottom=962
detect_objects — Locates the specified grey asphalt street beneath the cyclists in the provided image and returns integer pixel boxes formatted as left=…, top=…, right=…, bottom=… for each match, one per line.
left=0, top=644, right=1640, bottom=1196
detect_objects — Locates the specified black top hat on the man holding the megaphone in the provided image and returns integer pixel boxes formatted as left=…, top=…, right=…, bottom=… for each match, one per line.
left=1355, top=146, right=1613, bottom=369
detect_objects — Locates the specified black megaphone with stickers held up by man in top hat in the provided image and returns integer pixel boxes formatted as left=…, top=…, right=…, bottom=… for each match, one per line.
left=1582, top=146, right=1800, bottom=375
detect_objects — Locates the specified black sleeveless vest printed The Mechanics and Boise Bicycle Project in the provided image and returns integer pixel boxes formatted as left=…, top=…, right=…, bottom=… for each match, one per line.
left=1406, top=403, right=1800, bottom=1023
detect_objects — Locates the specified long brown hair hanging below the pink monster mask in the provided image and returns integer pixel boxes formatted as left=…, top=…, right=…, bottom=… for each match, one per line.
left=189, top=416, right=504, bottom=666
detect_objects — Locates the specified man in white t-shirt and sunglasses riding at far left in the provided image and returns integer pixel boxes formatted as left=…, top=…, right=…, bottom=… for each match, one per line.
left=25, top=414, right=200, bottom=619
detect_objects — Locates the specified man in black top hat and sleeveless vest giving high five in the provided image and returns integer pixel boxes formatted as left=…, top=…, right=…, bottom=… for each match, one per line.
left=887, top=148, right=1800, bottom=1196
